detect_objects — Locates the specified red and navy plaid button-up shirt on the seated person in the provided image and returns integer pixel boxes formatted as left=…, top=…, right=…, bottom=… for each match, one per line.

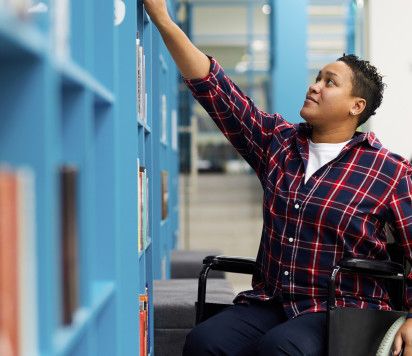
left=185, top=57, right=412, bottom=318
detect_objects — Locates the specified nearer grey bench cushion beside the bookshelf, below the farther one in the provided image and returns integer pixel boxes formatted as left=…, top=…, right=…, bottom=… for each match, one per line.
left=153, top=278, right=235, bottom=329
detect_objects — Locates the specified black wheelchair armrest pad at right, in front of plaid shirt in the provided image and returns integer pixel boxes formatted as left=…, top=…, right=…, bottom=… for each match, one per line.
left=338, top=258, right=404, bottom=278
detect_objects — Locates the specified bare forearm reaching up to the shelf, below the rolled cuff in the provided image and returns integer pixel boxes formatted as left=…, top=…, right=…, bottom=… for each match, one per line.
left=143, top=0, right=210, bottom=79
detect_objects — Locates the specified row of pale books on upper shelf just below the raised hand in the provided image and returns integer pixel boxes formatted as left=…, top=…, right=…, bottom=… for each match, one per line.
left=136, top=32, right=147, bottom=123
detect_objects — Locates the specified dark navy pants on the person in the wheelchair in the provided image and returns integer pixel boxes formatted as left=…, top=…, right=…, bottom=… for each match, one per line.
left=183, top=302, right=326, bottom=356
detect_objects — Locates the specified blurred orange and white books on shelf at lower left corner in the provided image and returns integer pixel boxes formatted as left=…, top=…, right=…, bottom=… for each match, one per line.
left=0, top=166, right=38, bottom=356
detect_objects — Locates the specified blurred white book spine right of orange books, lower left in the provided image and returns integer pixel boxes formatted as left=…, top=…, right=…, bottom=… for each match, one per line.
left=17, top=167, right=39, bottom=356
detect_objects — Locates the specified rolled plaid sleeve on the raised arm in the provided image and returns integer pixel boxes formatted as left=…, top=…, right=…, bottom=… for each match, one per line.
left=183, top=56, right=293, bottom=179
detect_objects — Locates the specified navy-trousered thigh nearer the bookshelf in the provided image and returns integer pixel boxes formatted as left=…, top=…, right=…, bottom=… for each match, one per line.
left=183, top=303, right=286, bottom=356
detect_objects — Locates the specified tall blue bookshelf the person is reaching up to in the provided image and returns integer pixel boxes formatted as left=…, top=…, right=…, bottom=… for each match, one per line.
left=0, top=0, right=179, bottom=356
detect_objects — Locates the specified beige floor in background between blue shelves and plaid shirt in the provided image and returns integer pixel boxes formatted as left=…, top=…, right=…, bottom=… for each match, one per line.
left=179, top=174, right=262, bottom=292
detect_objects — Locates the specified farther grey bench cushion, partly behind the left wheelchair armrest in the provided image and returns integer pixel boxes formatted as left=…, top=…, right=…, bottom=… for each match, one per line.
left=170, top=250, right=225, bottom=279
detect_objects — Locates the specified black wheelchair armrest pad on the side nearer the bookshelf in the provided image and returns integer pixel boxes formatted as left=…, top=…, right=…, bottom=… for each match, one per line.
left=203, top=255, right=256, bottom=274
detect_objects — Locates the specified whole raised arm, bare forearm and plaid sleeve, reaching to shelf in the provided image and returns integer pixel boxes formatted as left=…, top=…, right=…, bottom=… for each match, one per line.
left=144, top=0, right=292, bottom=181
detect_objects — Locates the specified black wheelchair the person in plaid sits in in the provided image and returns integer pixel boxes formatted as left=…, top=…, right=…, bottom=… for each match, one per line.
left=195, top=243, right=410, bottom=356
